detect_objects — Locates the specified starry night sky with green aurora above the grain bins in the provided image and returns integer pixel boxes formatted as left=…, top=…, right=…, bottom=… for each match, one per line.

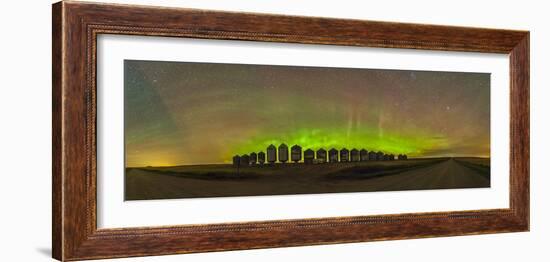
left=124, top=60, right=490, bottom=167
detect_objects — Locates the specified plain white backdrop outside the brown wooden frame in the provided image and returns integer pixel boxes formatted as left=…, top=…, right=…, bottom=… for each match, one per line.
left=0, top=0, right=550, bottom=261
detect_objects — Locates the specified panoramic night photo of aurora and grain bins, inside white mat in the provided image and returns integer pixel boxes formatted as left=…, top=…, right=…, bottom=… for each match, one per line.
left=124, top=60, right=491, bottom=201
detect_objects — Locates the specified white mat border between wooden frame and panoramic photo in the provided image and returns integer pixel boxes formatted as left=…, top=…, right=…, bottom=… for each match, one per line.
left=97, top=35, right=510, bottom=228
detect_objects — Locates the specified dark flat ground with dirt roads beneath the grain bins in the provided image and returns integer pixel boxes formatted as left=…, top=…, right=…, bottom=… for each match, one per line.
left=125, top=158, right=490, bottom=200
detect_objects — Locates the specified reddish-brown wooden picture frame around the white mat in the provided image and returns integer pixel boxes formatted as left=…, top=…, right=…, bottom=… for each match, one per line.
left=52, top=2, right=529, bottom=261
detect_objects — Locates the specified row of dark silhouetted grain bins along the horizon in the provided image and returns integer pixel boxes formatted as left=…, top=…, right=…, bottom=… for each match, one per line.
left=233, top=143, right=407, bottom=166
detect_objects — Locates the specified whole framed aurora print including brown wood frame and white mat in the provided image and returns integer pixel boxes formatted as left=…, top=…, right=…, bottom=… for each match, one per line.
left=52, top=1, right=529, bottom=261
